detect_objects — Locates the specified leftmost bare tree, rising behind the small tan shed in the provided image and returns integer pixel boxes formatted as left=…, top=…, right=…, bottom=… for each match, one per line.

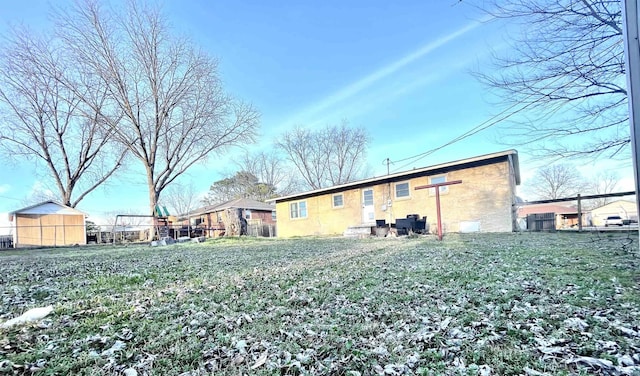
left=0, top=29, right=125, bottom=207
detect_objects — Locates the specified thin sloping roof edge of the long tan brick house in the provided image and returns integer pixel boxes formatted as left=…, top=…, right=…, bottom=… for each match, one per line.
left=267, top=149, right=520, bottom=202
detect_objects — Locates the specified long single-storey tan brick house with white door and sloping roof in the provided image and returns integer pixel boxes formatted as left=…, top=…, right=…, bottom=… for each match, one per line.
left=268, top=150, right=520, bottom=237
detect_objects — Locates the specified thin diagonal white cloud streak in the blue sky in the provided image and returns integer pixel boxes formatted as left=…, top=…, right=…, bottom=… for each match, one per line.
left=286, top=20, right=486, bottom=123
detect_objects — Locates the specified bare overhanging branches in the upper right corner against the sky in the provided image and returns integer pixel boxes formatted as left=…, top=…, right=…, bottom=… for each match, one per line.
left=478, top=0, right=629, bottom=158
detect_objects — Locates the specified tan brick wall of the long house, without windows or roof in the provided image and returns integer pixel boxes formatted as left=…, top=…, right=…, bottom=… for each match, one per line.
left=276, top=158, right=516, bottom=237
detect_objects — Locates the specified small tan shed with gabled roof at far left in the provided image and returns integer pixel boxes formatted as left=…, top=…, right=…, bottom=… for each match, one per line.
left=9, top=201, right=87, bottom=248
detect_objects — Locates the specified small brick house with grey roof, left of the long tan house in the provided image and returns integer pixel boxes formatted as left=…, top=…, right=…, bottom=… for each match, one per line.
left=182, top=198, right=276, bottom=237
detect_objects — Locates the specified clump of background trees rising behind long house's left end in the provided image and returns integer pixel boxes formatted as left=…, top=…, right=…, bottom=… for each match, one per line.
left=203, top=120, right=370, bottom=204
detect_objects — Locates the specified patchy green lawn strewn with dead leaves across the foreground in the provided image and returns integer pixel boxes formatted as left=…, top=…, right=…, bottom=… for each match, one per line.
left=0, top=234, right=640, bottom=376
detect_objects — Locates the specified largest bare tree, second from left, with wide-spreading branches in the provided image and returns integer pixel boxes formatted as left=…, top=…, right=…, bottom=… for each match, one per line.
left=52, top=0, right=259, bottom=217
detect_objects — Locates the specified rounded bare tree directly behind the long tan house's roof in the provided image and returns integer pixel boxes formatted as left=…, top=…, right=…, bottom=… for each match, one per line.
left=276, top=121, right=369, bottom=189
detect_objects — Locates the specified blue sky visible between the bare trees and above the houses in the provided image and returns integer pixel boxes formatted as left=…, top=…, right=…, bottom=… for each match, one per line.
left=0, top=0, right=633, bottom=222
